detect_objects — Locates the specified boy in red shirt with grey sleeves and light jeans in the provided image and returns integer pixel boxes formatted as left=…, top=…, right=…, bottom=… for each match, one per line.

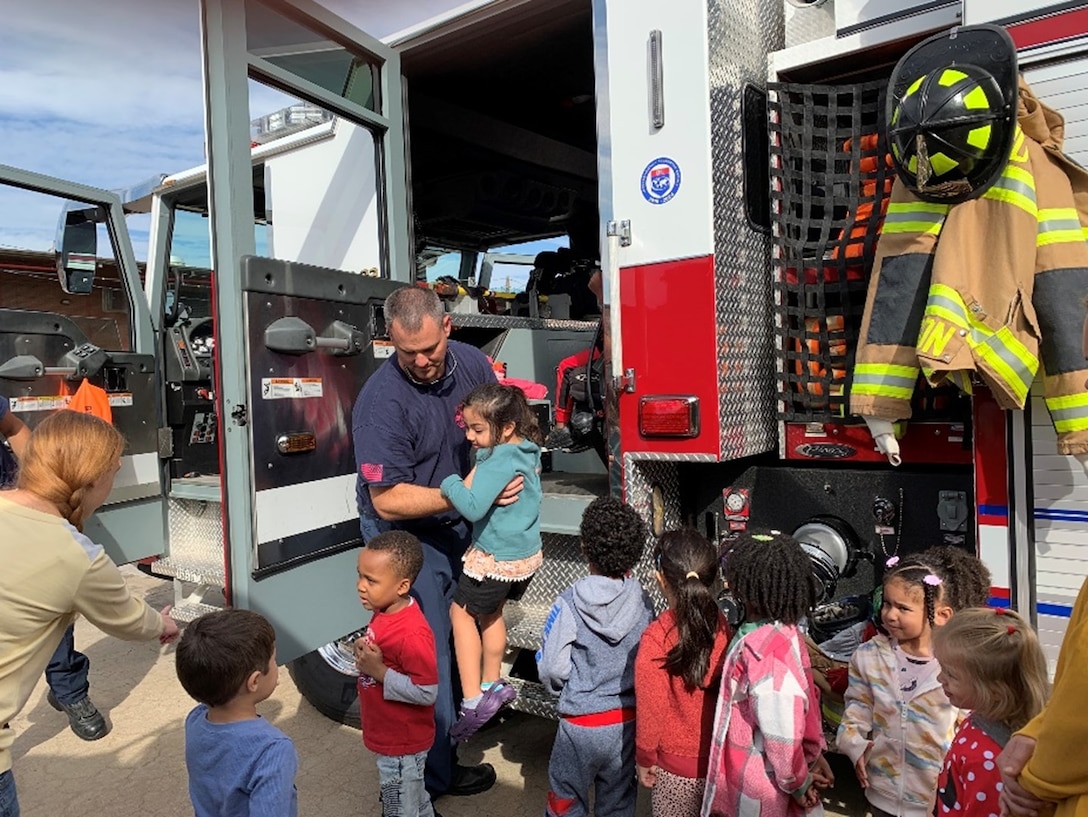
left=355, top=531, right=438, bottom=817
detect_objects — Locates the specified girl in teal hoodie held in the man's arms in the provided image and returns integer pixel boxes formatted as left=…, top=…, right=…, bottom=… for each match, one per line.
left=441, top=383, right=543, bottom=741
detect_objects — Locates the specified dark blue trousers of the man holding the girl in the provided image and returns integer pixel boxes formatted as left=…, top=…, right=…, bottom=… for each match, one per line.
left=359, top=515, right=471, bottom=797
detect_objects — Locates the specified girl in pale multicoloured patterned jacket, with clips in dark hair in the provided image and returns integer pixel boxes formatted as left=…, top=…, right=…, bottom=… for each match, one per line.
left=836, top=556, right=959, bottom=817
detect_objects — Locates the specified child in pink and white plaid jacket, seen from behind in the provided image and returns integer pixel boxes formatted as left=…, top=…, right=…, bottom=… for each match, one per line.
left=702, top=531, right=833, bottom=817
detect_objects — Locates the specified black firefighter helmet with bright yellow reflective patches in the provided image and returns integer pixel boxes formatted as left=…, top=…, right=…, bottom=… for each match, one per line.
left=888, top=25, right=1017, bottom=205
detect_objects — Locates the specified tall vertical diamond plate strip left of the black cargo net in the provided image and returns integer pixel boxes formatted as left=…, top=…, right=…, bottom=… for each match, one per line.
left=707, top=0, right=783, bottom=459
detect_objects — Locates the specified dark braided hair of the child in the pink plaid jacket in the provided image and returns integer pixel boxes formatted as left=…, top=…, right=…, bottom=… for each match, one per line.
left=722, top=531, right=816, bottom=624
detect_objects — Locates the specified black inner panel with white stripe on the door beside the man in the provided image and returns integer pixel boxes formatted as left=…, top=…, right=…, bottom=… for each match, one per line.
left=243, top=257, right=398, bottom=574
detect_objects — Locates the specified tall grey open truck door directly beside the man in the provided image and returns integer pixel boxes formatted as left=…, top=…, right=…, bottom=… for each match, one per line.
left=201, top=0, right=412, bottom=661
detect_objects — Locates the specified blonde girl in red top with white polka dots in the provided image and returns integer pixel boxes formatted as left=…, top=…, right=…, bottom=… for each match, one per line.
left=934, top=608, right=1049, bottom=817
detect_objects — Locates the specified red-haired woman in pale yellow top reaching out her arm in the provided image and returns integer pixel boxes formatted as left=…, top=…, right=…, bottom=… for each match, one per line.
left=0, top=411, right=177, bottom=817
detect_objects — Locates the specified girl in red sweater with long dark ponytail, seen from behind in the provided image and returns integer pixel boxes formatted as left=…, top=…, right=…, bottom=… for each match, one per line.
left=634, top=528, right=729, bottom=817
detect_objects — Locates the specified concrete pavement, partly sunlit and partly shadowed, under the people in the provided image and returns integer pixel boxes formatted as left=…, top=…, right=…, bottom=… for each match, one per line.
left=4, top=568, right=865, bottom=817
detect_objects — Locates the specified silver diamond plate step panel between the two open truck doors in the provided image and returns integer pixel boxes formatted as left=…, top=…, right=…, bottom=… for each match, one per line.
left=163, top=498, right=226, bottom=586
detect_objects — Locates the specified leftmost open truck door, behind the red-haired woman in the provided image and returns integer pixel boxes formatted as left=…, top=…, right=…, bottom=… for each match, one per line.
left=0, top=165, right=164, bottom=564
